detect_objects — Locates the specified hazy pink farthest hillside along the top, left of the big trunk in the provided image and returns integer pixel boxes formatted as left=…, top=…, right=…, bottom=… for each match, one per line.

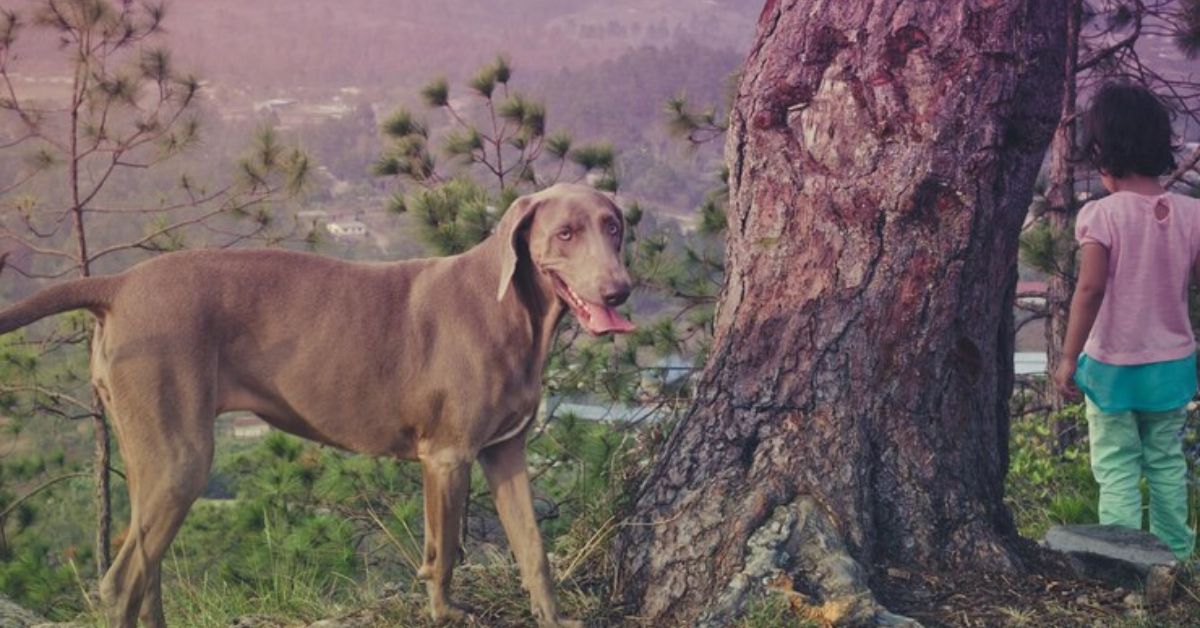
left=9, top=0, right=762, bottom=92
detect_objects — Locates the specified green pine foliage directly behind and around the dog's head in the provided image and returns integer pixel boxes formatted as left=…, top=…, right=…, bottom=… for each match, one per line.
left=373, top=56, right=724, bottom=403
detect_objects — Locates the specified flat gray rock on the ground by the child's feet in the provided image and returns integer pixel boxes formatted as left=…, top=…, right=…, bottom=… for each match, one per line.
left=1043, top=525, right=1178, bottom=605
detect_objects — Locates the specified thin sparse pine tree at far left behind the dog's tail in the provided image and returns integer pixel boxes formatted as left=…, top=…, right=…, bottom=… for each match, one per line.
left=0, top=0, right=310, bottom=590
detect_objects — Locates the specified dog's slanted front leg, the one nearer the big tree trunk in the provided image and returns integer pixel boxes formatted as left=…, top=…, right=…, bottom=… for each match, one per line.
left=479, top=435, right=583, bottom=627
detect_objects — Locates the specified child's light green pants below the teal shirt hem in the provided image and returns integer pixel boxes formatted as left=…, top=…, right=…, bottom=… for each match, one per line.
left=1087, top=400, right=1195, bottom=560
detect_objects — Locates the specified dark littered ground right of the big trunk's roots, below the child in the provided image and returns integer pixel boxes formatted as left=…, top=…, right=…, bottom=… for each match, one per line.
left=871, top=543, right=1200, bottom=628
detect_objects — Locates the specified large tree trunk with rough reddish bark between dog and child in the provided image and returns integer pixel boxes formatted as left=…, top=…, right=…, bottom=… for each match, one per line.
left=617, top=0, right=1064, bottom=626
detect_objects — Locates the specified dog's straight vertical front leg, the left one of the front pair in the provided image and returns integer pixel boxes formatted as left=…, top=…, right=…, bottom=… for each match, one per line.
left=418, top=450, right=470, bottom=621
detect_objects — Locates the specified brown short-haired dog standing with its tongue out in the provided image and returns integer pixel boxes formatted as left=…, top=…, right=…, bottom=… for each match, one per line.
left=0, top=185, right=632, bottom=627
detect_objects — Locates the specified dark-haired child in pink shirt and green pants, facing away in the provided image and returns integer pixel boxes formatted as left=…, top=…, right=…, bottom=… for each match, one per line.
left=1054, top=84, right=1200, bottom=560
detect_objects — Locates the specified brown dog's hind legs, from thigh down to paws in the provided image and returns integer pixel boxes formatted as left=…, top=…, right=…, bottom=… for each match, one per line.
left=97, top=364, right=215, bottom=628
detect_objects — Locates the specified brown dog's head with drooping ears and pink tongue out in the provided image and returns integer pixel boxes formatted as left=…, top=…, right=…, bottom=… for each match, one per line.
left=496, top=184, right=634, bottom=335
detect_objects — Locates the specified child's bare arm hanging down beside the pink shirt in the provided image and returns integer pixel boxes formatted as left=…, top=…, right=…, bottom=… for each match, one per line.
left=1054, top=243, right=1108, bottom=400
